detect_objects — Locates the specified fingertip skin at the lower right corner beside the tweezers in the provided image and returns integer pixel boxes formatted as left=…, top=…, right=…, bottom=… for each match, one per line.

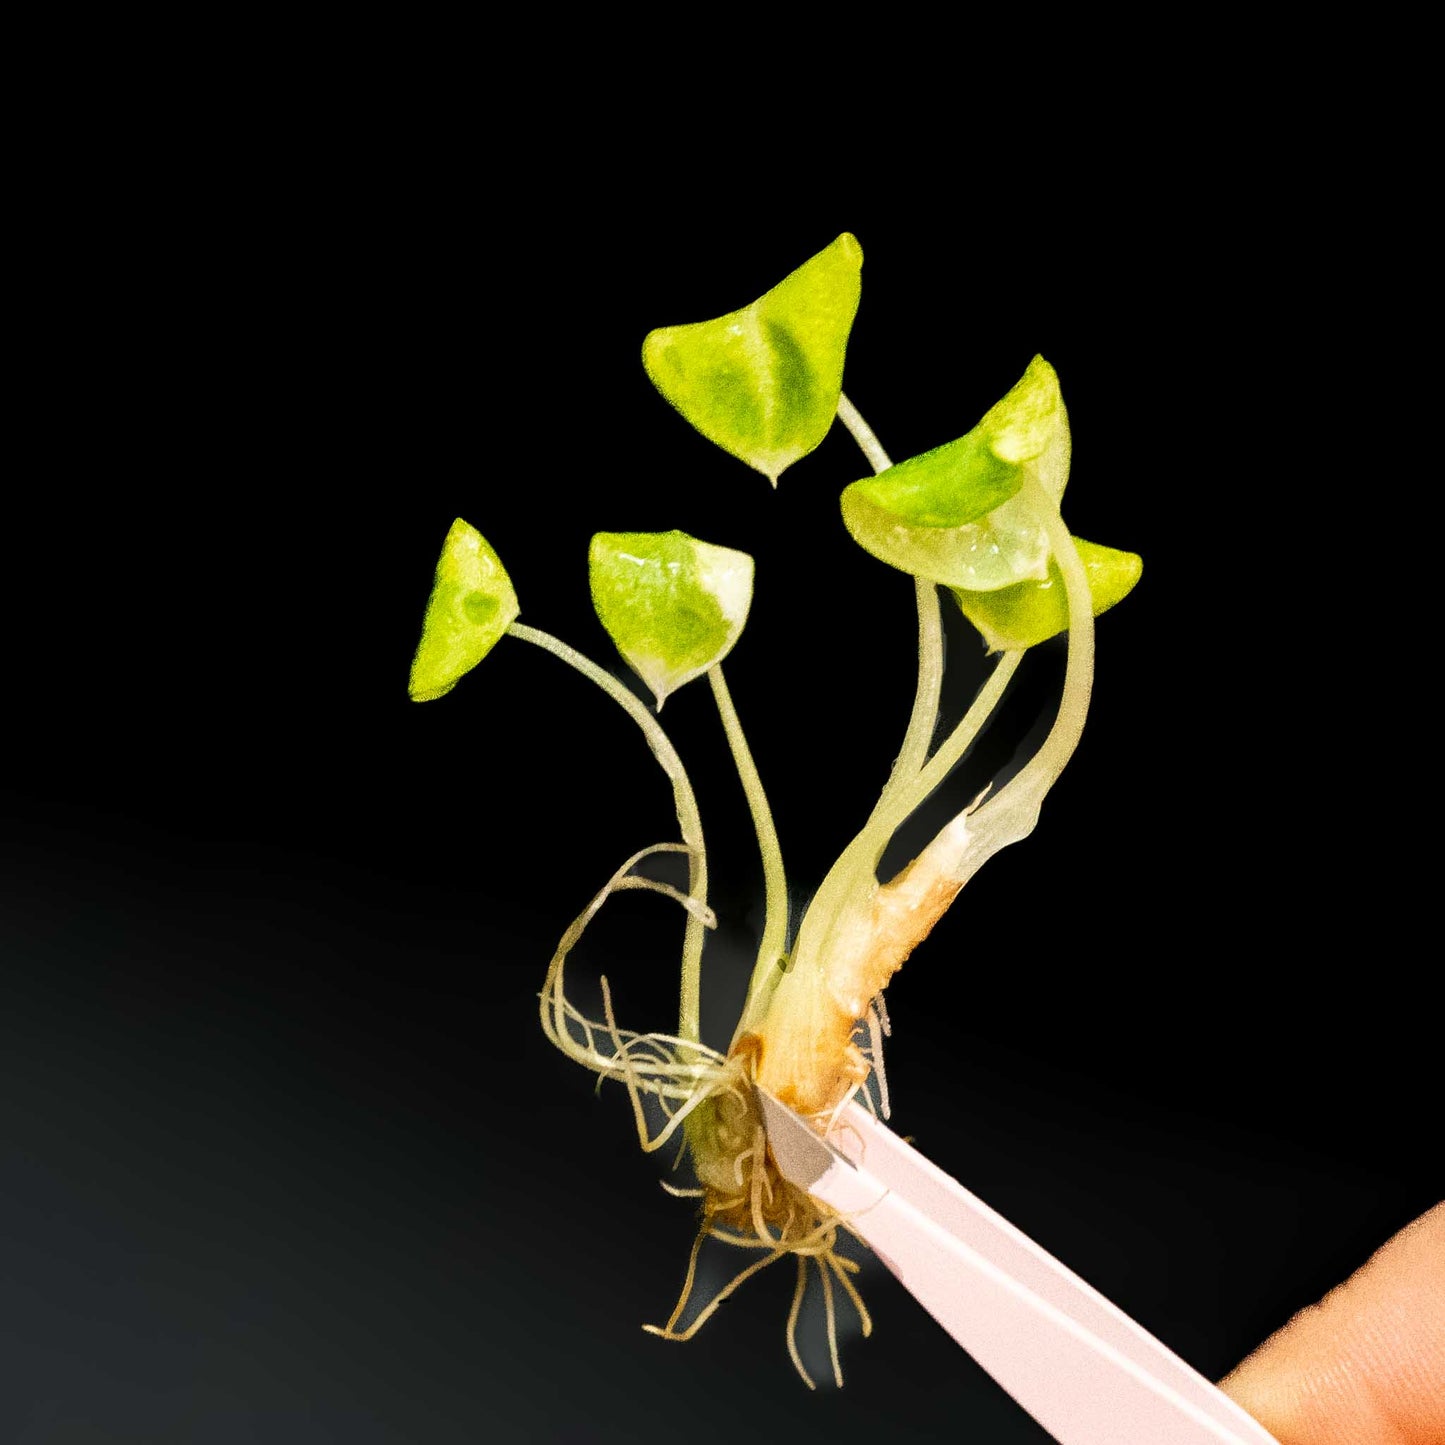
left=1220, top=1204, right=1445, bottom=1445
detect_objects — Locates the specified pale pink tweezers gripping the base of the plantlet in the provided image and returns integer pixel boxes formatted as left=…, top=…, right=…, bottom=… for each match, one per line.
left=757, top=1090, right=1279, bottom=1445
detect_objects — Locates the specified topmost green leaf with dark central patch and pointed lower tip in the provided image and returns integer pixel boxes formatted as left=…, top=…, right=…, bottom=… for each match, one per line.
left=642, top=233, right=863, bottom=487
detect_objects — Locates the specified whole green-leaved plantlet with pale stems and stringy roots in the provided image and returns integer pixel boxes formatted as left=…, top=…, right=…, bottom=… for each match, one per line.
left=410, top=234, right=1142, bottom=1386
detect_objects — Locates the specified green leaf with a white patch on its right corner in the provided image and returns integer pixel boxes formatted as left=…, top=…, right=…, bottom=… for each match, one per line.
left=588, top=532, right=753, bottom=709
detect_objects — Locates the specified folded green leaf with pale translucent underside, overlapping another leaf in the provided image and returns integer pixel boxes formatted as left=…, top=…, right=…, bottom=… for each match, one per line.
left=842, top=357, right=1069, bottom=591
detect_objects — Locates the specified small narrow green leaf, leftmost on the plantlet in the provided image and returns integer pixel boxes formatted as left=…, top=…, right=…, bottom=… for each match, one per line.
left=409, top=517, right=519, bottom=702
